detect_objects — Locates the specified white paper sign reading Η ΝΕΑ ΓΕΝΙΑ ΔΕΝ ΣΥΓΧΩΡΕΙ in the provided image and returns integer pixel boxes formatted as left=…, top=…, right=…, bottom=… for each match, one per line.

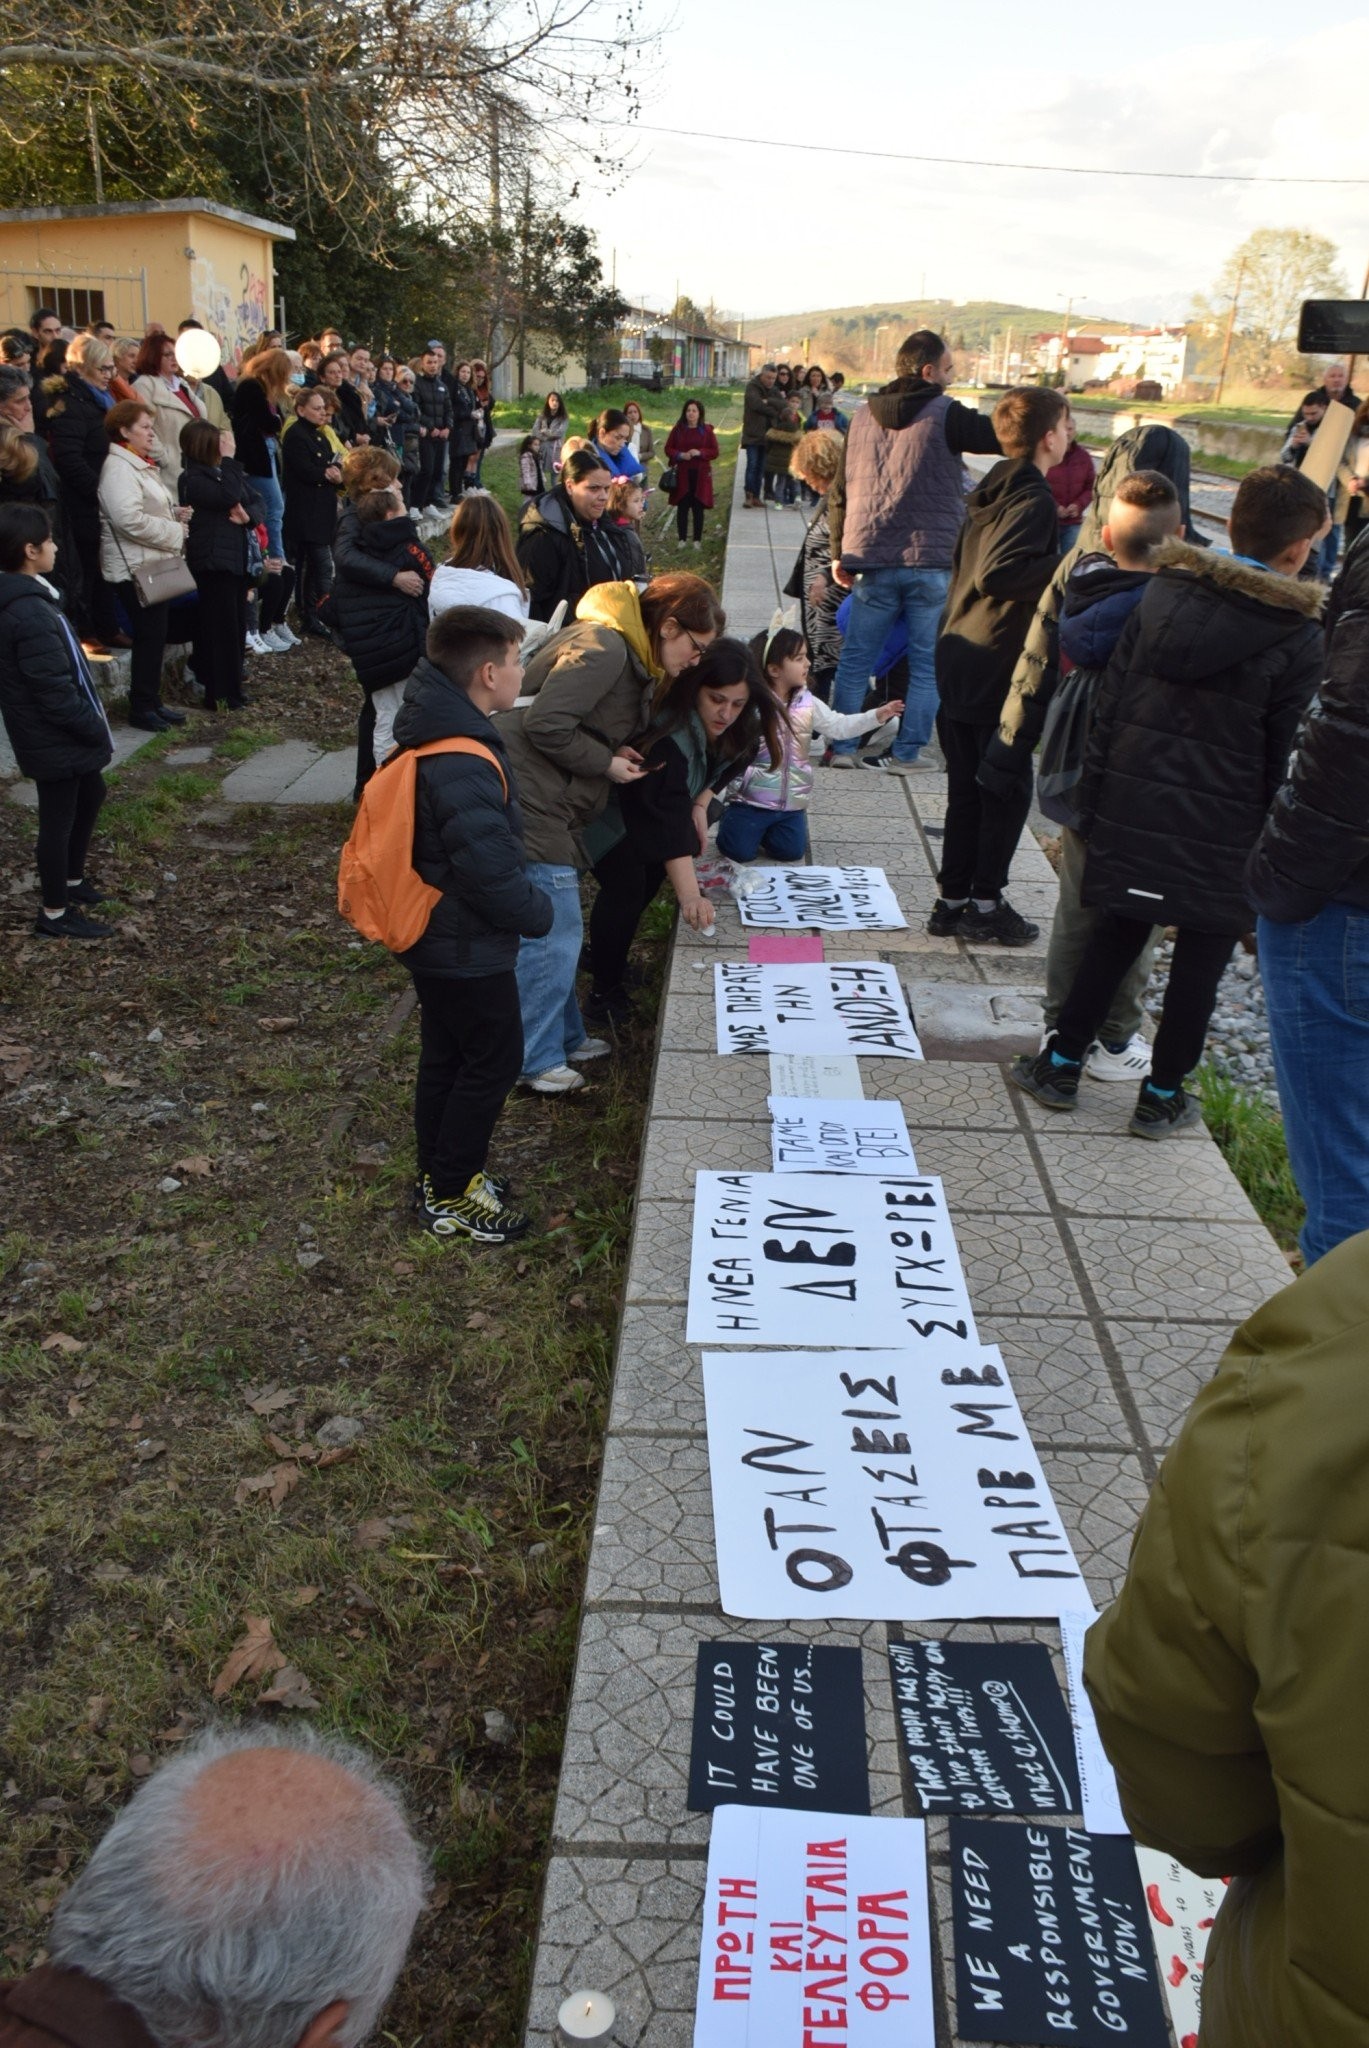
left=687, top=1174, right=978, bottom=1366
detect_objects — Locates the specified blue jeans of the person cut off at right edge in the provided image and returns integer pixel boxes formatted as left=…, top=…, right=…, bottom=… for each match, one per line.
left=1258, top=903, right=1369, bottom=1266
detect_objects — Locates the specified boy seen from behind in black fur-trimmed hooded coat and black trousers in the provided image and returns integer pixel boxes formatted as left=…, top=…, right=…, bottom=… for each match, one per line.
left=1010, top=469, right=1330, bottom=1139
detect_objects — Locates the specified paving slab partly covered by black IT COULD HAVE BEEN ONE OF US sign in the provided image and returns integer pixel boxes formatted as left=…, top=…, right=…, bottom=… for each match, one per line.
left=553, top=1612, right=904, bottom=1851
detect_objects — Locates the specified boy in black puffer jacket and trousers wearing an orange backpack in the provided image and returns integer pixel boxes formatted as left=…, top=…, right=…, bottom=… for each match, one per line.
left=396, top=604, right=551, bottom=1245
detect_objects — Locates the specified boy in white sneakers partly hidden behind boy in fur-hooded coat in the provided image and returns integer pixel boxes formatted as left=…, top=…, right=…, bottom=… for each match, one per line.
left=1037, top=469, right=1183, bottom=1081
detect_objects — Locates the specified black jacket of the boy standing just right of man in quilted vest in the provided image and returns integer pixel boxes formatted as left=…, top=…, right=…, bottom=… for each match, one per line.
left=937, top=455, right=1060, bottom=725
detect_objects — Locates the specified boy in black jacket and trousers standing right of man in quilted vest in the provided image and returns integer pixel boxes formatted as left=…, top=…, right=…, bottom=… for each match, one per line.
left=926, top=387, right=1070, bottom=946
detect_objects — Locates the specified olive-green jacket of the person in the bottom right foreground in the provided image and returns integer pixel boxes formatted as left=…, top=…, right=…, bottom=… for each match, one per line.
left=1084, top=1233, right=1369, bottom=2048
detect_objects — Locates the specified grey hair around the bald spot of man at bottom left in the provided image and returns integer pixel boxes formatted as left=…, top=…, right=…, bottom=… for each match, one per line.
left=49, top=1726, right=426, bottom=2048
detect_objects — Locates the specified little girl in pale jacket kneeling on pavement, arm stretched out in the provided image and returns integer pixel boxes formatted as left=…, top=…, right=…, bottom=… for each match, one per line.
left=717, top=627, right=904, bottom=860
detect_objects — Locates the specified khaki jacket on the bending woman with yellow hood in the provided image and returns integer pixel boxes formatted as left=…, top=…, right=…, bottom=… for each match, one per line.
left=496, top=584, right=654, bottom=868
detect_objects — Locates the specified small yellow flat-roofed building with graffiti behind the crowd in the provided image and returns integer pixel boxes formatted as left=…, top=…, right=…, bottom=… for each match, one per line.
left=0, top=199, right=295, bottom=362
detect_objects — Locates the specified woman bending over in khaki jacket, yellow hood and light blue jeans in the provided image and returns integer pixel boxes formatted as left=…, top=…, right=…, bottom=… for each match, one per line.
left=498, top=573, right=725, bottom=1096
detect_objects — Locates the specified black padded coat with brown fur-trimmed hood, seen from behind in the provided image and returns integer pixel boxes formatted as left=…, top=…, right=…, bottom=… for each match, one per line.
left=1078, top=541, right=1322, bottom=934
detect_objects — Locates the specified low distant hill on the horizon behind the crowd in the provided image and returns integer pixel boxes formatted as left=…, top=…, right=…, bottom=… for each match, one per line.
left=746, top=299, right=1131, bottom=377
